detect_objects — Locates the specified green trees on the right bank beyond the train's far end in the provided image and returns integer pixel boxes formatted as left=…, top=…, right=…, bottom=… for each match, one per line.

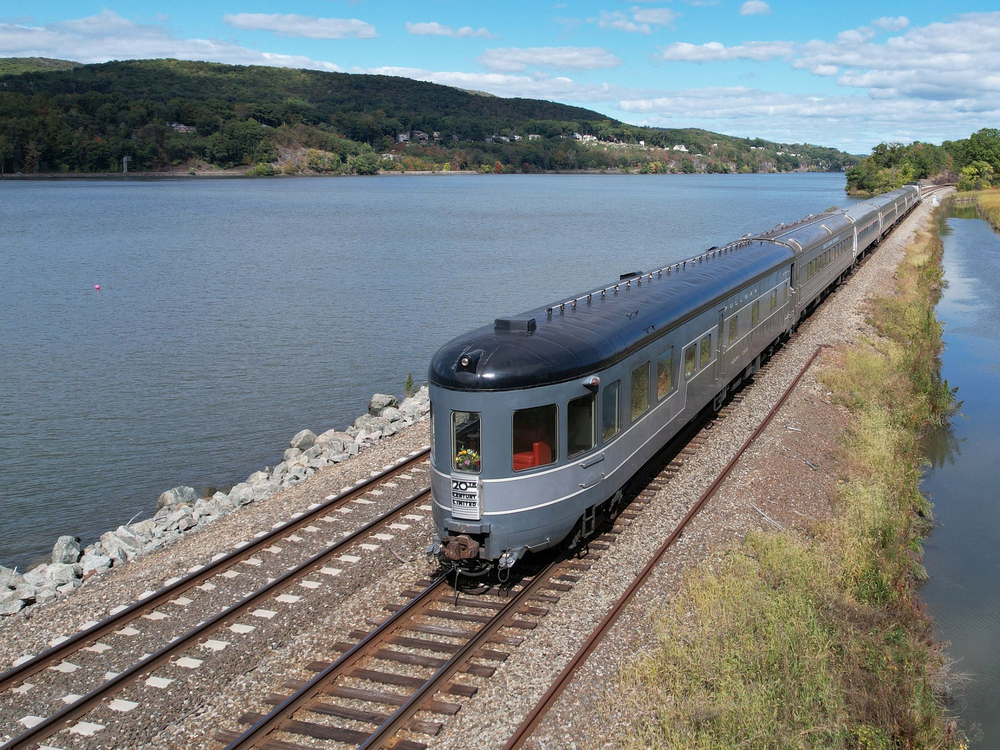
left=847, top=128, right=1000, bottom=195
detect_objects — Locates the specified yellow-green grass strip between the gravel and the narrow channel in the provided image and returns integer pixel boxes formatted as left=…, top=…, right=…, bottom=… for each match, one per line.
left=605, top=209, right=965, bottom=750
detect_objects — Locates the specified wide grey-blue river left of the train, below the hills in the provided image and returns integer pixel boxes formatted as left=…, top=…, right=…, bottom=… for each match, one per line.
left=0, top=175, right=851, bottom=566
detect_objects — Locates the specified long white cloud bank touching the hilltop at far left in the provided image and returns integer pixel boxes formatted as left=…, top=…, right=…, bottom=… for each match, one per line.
left=0, top=10, right=341, bottom=71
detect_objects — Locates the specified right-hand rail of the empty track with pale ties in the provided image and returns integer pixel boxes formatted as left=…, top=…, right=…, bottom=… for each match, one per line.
left=0, top=487, right=430, bottom=750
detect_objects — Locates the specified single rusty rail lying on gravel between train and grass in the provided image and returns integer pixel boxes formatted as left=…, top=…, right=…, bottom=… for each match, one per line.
left=503, top=344, right=827, bottom=750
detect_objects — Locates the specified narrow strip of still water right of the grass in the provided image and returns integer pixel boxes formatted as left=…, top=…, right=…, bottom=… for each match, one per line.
left=923, top=201, right=1000, bottom=747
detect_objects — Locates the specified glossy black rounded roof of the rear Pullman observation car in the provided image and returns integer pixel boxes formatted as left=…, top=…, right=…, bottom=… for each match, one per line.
left=429, top=240, right=795, bottom=391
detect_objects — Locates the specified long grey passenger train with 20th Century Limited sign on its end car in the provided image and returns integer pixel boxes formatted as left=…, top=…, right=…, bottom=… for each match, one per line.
left=428, top=185, right=921, bottom=575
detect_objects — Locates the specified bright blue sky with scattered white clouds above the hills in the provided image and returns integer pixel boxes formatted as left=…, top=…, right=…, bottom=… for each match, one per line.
left=0, top=0, right=1000, bottom=154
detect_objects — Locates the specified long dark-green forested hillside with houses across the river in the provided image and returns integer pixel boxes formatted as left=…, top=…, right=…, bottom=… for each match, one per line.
left=0, top=58, right=857, bottom=174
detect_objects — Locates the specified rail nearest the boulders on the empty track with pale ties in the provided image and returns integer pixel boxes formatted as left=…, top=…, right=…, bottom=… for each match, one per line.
left=0, top=448, right=430, bottom=693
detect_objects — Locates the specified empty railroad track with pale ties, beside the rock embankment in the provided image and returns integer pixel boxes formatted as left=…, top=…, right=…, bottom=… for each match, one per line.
left=0, top=448, right=430, bottom=750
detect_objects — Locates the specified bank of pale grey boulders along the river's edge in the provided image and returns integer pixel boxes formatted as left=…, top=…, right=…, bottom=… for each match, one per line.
left=0, top=386, right=431, bottom=617
